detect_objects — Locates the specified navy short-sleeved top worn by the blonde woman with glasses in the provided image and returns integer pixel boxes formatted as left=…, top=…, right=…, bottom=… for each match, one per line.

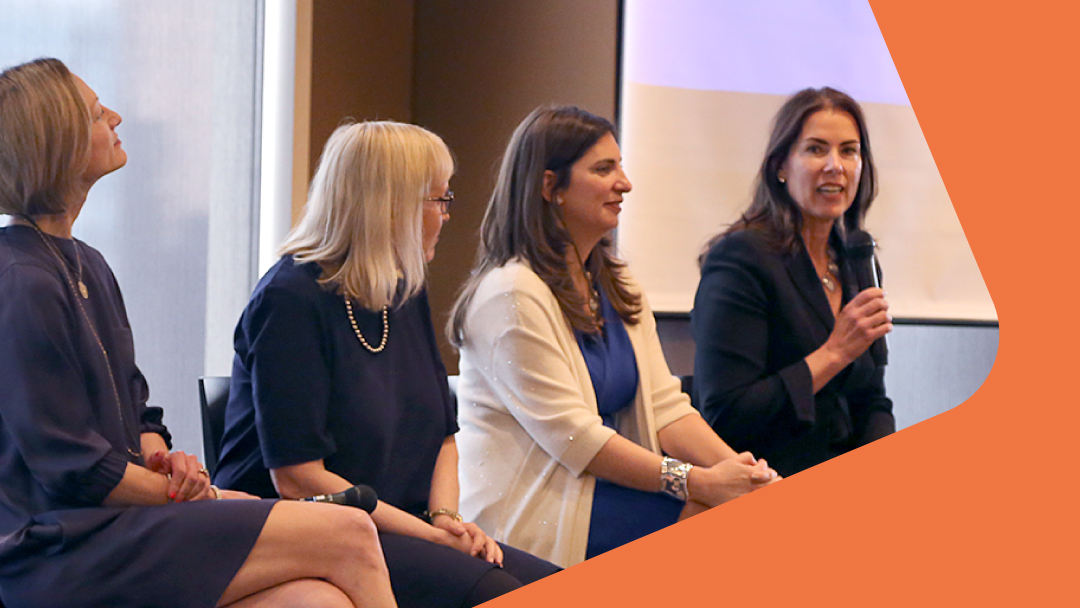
left=214, top=256, right=458, bottom=514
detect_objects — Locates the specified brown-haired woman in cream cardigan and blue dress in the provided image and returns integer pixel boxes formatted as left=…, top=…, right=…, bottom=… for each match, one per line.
left=448, top=107, right=778, bottom=567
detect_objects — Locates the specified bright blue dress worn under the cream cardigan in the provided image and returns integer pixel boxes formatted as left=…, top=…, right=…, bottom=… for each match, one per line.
left=573, top=292, right=684, bottom=559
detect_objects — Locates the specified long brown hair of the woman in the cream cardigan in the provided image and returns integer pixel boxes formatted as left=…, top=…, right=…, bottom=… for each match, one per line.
left=447, top=106, right=642, bottom=347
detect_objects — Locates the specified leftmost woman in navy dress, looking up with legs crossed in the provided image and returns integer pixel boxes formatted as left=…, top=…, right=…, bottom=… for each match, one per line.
left=0, top=59, right=395, bottom=608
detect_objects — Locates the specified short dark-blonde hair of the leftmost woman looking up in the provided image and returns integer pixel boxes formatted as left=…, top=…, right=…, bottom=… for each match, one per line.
left=0, top=58, right=91, bottom=217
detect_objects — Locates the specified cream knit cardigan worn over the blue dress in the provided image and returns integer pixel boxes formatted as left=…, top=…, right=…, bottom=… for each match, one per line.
left=457, top=262, right=698, bottom=567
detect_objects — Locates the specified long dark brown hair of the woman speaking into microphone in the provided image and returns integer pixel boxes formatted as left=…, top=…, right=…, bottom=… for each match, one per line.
left=698, top=86, right=877, bottom=264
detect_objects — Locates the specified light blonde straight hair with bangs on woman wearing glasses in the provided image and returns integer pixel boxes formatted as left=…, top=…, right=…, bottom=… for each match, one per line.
left=280, top=121, right=454, bottom=310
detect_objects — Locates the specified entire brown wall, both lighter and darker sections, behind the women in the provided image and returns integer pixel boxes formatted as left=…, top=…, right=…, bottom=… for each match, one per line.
left=311, top=0, right=619, bottom=374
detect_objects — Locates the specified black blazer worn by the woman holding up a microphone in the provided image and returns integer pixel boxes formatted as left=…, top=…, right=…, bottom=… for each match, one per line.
left=691, top=230, right=896, bottom=475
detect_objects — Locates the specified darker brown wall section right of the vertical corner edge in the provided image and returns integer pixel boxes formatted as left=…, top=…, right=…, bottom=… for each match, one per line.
left=413, top=0, right=619, bottom=374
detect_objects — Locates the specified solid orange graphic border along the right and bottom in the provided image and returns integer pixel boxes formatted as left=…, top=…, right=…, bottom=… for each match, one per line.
left=489, top=0, right=1080, bottom=608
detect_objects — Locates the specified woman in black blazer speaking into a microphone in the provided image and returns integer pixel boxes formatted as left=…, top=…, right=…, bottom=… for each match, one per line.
left=691, top=87, right=895, bottom=475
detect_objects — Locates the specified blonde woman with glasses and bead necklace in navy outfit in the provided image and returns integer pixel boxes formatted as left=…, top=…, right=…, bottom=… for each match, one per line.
left=215, top=122, right=557, bottom=608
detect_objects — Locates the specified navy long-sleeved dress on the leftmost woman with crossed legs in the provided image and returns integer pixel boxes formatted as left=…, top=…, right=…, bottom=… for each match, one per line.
left=0, top=226, right=272, bottom=608
